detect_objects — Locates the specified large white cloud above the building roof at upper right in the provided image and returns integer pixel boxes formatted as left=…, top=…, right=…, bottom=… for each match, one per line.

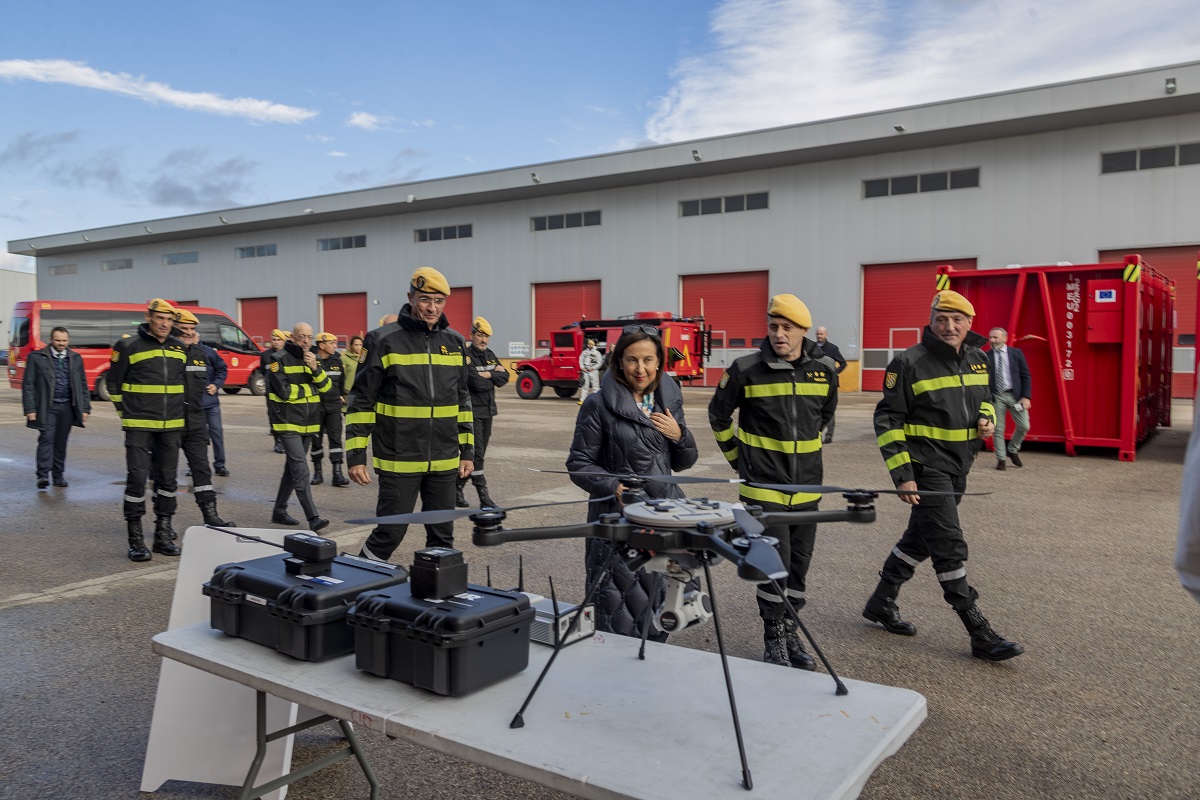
left=646, top=0, right=1200, bottom=143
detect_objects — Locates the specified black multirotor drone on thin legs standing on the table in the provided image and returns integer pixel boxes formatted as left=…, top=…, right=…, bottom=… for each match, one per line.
left=347, top=470, right=988, bottom=789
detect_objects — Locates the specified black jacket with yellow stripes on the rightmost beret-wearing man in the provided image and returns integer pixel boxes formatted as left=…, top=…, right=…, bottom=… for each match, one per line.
left=875, top=326, right=996, bottom=486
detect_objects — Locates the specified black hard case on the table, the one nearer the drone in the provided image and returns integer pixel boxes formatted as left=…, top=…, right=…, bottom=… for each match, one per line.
left=347, top=584, right=534, bottom=697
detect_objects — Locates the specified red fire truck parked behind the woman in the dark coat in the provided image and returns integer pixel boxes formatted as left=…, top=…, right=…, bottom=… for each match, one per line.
left=516, top=311, right=712, bottom=399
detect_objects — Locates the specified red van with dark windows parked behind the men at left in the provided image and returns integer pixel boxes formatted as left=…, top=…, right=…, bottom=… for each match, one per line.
left=8, top=300, right=266, bottom=401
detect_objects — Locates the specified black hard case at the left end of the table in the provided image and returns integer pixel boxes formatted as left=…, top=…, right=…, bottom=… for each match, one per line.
left=204, top=553, right=407, bottom=661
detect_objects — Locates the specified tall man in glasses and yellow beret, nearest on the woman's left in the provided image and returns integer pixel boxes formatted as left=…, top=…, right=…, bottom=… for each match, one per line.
left=346, top=266, right=474, bottom=561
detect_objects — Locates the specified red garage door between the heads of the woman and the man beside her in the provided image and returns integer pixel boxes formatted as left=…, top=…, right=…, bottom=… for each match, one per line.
left=682, top=270, right=770, bottom=386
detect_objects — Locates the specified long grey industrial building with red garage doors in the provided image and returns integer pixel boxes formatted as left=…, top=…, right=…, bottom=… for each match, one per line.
left=8, top=61, right=1200, bottom=397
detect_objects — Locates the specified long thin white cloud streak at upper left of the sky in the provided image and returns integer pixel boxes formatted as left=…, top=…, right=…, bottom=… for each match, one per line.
left=0, top=59, right=317, bottom=124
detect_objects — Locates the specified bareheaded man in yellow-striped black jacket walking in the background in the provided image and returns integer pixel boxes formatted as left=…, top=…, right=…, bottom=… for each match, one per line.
left=266, top=323, right=331, bottom=533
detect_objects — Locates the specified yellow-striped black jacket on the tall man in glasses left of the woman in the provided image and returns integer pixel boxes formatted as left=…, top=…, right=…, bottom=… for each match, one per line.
left=346, top=305, right=475, bottom=474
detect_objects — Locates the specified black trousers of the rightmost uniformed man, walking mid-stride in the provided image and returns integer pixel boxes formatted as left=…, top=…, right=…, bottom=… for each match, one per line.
left=876, top=464, right=979, bottom=610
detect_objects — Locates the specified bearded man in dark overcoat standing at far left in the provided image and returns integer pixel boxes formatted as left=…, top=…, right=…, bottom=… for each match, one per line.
left=20, top=326, right=91, bottom=489
